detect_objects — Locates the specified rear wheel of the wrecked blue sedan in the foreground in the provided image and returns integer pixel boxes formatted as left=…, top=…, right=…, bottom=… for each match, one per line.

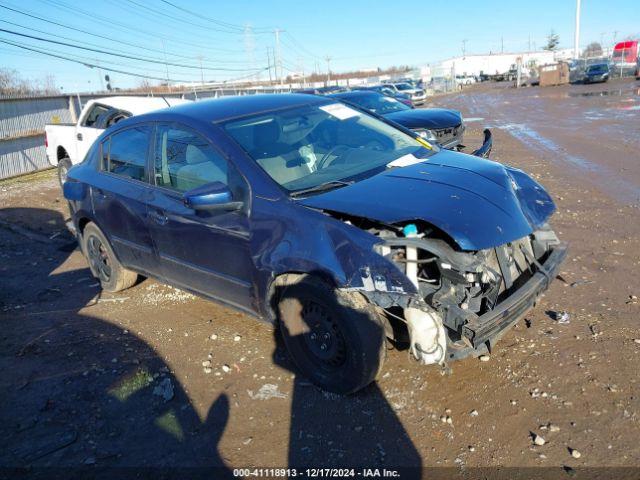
left=82, top=222, right=138, bottom=292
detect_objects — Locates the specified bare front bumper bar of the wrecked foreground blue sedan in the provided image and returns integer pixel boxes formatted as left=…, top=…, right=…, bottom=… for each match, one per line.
left=456, top=243, right=567, bottom=348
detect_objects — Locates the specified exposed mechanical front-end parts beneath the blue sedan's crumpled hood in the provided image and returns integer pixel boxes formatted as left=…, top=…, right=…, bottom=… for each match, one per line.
left=370, top=223, right=559, bottom=352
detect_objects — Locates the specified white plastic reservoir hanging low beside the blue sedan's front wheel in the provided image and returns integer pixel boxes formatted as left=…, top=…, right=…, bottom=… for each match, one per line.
left=404, top=307, right=447, bottom=365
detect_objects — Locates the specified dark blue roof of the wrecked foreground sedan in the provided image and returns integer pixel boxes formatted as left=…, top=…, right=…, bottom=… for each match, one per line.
left=148, top=93, right=330, bottom=122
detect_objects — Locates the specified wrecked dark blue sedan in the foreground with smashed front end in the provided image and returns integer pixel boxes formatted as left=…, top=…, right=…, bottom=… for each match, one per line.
left=64, top=95, right=566, bottom=393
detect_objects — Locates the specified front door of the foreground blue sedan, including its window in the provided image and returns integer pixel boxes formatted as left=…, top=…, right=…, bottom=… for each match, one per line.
left=147, top=124, right=254, bottom=311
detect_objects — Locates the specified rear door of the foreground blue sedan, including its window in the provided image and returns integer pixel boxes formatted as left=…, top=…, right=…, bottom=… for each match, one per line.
left=91, top=124, right=157, bottom=274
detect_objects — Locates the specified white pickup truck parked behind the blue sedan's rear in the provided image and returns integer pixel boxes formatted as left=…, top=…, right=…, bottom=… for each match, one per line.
left=44, top=97, right=190, bottom=185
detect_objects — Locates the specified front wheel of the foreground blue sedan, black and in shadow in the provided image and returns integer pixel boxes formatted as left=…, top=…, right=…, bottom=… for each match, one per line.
left=277, top=275, right=386, bottom=394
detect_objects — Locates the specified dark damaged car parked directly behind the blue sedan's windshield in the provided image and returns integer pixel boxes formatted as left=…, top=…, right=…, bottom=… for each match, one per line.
left=330, top=91, right=493, bottom=157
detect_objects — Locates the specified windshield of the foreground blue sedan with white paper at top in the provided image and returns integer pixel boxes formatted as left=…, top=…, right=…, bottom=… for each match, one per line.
left=224, top=103, right=436, bottom=192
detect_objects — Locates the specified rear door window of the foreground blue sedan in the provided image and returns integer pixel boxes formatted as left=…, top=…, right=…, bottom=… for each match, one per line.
left=102, top=125, right=151, bottom=181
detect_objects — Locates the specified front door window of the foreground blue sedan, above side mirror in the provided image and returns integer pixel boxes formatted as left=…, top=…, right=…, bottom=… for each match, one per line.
left=154, top=125, right=232, bottom=192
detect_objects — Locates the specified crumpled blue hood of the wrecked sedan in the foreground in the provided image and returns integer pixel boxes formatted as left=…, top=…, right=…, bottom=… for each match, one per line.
left=299, top=150, right=555, bottom=250
